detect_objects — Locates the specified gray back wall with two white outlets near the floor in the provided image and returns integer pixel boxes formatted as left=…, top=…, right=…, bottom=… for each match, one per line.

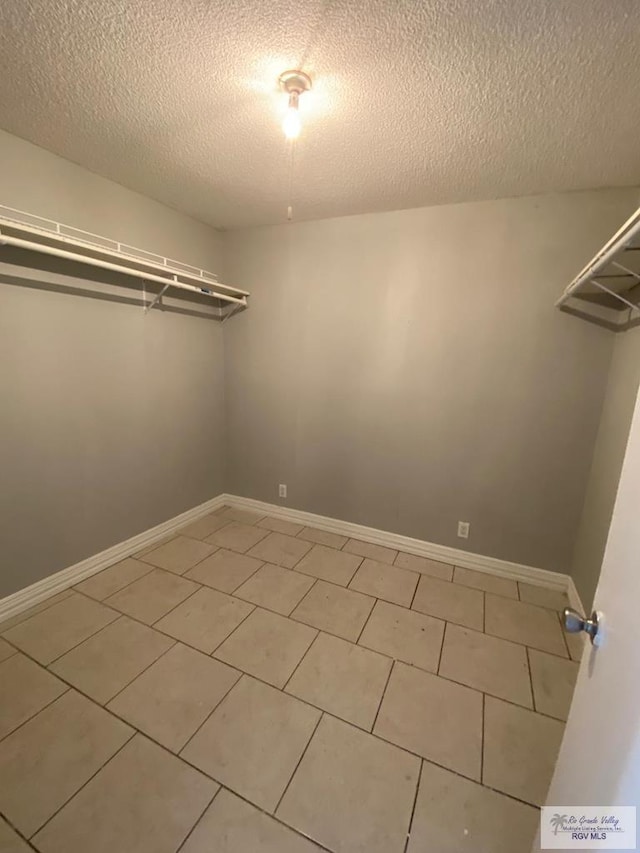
left=225, top=190, right=637, bottom=572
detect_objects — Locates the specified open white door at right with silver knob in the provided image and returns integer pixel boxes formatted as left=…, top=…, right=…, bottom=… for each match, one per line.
left=534, top=382, right=640, bottom=851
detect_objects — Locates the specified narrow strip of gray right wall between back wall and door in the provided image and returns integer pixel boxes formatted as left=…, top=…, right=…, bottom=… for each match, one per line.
left=571, top=328, right=640, bottom=610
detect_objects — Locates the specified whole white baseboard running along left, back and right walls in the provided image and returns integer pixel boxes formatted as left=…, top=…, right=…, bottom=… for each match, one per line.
left=0, top=494, right=568, bottom=622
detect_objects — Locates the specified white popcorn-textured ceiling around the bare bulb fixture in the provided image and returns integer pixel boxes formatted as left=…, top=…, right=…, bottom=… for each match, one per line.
left=0, top=0, right=640, bottom=228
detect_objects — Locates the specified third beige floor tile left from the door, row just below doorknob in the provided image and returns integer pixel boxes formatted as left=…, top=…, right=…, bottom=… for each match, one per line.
left=358, top=601, right=445, bottom=672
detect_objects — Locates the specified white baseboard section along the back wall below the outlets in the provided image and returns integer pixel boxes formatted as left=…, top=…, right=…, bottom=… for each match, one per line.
left=222, top=495, right=575, bottom=591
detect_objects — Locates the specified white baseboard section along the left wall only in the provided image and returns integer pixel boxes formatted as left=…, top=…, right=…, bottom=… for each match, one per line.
left=0, top=495, right=224, bottom=622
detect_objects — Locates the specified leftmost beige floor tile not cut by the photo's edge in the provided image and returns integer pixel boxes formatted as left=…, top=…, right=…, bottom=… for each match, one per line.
left=51, top=616, right=173, bottom=704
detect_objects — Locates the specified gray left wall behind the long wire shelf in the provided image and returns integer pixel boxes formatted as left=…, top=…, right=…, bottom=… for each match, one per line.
left=0, top=133, right=224, bottom=596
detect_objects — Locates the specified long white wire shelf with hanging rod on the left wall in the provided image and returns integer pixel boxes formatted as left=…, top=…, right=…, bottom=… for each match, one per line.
left=0, top=204, right=249, bottom=319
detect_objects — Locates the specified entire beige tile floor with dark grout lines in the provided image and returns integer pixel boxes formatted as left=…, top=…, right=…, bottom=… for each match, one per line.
left=0, top=508, right=581, bottom=853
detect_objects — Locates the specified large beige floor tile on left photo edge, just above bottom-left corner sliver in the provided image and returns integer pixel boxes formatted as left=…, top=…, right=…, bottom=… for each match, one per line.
left=0, top=690, right=133, bottom=836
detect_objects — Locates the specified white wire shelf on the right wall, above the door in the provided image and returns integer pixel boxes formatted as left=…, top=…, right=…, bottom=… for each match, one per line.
left=556, top=208, right=640, bottom=330
